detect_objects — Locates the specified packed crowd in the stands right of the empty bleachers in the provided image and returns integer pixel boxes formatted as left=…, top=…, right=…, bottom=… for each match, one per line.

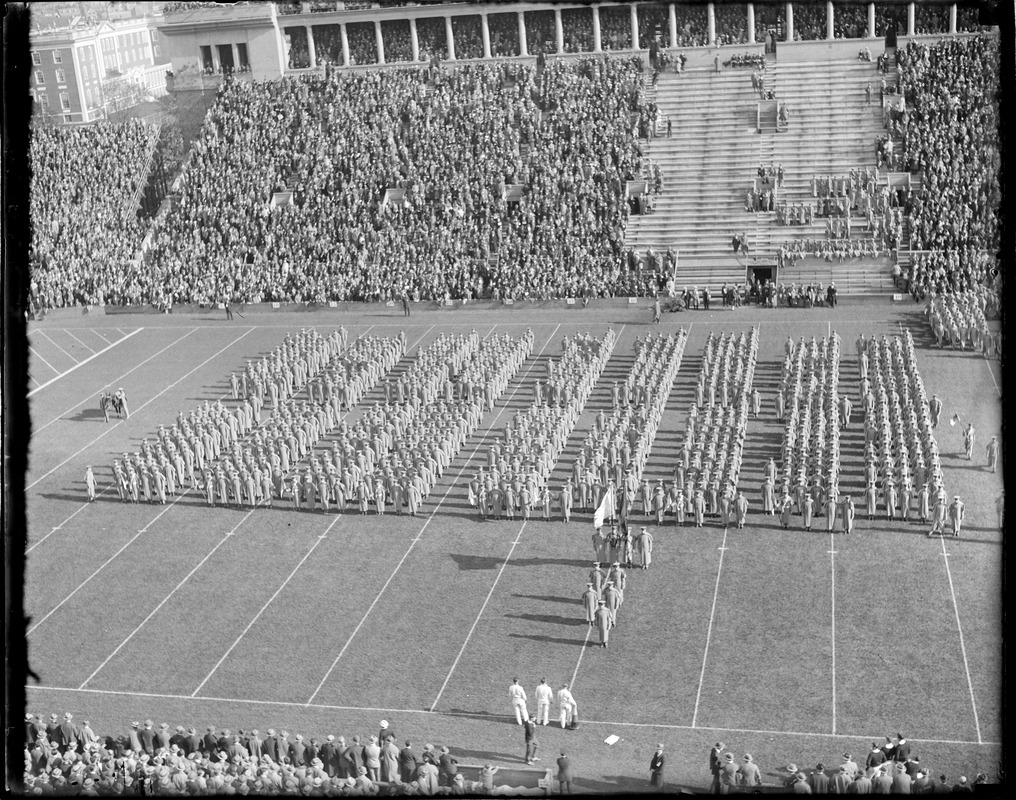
left=899, top=37, right=1001, bottom=292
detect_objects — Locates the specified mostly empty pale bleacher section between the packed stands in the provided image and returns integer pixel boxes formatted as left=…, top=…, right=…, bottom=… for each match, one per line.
left=626, top=60, right=892, bottom=295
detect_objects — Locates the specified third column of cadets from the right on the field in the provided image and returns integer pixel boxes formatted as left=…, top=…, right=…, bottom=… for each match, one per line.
left=675, top=328, right=759, bottom=528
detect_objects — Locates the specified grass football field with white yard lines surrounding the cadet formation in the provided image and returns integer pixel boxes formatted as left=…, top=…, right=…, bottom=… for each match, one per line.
left=19, top=302, right=1002, bottom=792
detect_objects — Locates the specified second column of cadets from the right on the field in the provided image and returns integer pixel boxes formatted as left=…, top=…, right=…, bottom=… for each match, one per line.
left=776, top=332, right=852, bottom=532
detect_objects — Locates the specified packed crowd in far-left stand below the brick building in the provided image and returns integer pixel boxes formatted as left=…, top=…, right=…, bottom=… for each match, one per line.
left=28, top=119, right=155, bottom=308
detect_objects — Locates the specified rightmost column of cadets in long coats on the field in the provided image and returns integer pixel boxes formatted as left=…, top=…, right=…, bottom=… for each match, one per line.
left=858, top=330, right=948, bottom=531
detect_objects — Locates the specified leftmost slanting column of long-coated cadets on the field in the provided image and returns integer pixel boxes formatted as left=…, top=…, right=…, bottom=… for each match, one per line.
left=113, top=328, right=355, bottom=503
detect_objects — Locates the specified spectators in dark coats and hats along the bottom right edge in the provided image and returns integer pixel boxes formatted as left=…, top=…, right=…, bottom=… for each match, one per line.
left=709, top=733, right=988, bottom=795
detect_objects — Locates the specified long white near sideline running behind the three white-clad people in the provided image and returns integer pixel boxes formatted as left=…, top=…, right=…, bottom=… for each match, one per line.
left=24, top=684, right=1002, bottom=747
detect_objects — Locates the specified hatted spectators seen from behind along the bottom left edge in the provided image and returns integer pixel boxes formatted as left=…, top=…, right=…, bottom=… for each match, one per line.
left=22, top=711, right=540, bottom=797
